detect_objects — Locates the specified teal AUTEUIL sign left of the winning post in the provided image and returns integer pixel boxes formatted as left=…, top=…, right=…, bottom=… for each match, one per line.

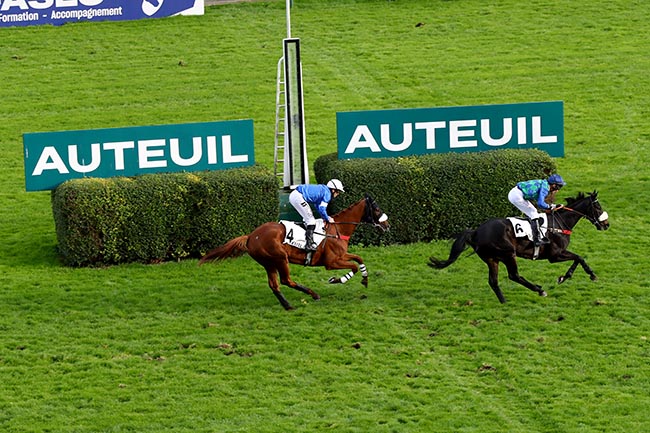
left=23, top=119, right=255, bottom=191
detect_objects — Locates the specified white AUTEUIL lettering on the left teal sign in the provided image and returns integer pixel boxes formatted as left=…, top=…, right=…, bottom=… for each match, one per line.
left=32, top=135, right=249, bottom=176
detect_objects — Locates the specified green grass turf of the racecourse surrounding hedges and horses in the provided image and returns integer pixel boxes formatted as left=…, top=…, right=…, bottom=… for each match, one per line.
left=0, top=0, right=650, bottom=433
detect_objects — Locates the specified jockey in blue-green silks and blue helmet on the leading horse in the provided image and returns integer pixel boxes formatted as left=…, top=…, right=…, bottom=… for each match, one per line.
left=508, top=174, right=566, bottom=247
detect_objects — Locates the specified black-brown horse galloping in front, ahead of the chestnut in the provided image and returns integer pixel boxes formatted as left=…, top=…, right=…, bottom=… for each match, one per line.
left=427, top=191, right=609, bottom=303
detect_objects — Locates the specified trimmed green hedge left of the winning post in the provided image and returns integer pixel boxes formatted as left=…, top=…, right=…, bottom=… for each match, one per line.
left=52, top=166, right=279, bottom=266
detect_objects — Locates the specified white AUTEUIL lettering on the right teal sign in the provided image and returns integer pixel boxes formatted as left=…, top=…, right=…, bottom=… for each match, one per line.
left=344, top=116, right=558, bottom=154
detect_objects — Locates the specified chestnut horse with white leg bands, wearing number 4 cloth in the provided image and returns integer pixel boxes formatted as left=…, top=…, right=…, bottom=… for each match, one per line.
left=199, top=195, right=390, bottom=310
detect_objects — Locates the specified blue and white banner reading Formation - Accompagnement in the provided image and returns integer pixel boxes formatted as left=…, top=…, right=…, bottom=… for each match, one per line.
left=0, top=0, right=205, bottom=27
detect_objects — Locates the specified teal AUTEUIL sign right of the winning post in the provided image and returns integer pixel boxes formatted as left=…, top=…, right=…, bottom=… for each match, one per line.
left=336, top=101, right=564, bottom=159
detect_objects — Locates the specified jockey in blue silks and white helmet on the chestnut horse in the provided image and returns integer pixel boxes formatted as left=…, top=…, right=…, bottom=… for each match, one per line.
left=289, top=179, right=345, bottom=251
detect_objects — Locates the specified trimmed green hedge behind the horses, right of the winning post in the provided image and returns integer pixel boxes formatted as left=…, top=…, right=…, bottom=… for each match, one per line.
left=314, top=150, right=556, bottom=245
